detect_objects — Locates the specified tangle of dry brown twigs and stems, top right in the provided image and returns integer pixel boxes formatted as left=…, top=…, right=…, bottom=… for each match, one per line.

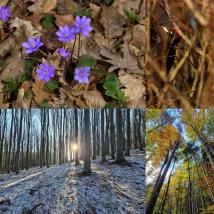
left=146, top=0, right=214, bottom=108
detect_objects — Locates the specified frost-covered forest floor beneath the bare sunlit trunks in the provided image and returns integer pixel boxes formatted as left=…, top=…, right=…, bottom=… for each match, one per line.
left=0, top=153, right=145, bottom=214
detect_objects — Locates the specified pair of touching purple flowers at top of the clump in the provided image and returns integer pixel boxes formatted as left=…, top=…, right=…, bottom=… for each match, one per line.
left=56, top=16, right=93, bottom=42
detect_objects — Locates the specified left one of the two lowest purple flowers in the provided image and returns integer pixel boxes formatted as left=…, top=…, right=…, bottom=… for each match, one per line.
left=36, top=62, right=55, bottom=82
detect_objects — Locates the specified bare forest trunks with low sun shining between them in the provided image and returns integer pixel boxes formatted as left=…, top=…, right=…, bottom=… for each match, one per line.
left=0, top=109, right=145, bottom=173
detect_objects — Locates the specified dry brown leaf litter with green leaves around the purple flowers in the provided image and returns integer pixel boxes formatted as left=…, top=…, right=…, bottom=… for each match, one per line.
left=0, top=0, right=146, bottom=108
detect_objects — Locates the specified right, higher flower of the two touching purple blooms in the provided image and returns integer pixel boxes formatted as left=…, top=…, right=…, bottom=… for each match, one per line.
left=74, top=16, right=93, bottom=36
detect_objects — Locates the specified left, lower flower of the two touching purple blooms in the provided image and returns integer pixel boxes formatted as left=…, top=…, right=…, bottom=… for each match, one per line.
left=56, top=25, right=75, bottom=42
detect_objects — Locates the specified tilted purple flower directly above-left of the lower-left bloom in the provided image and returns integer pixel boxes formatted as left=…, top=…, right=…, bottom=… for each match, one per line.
left=22, top=36, right=43, bottom=54
